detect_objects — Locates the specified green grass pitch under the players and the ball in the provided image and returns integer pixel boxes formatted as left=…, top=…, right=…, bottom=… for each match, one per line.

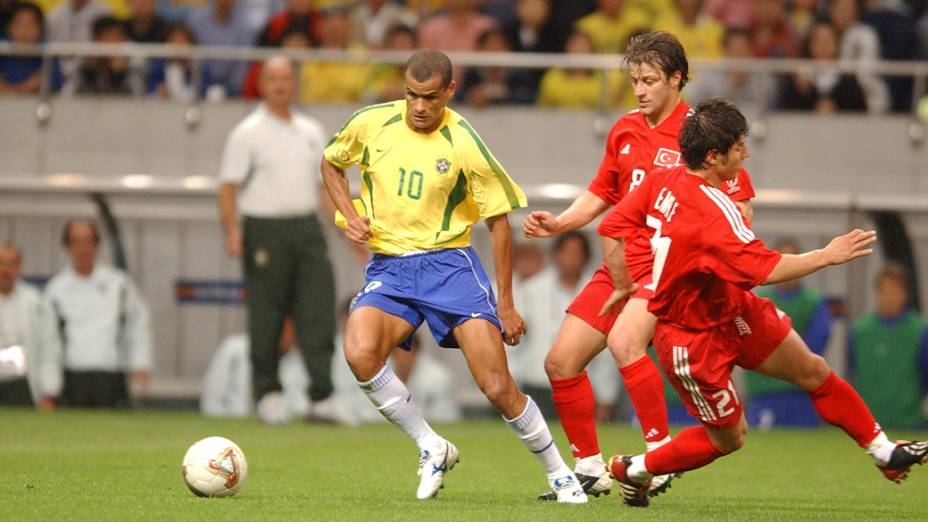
left=0, top=410, right=928, bottom=522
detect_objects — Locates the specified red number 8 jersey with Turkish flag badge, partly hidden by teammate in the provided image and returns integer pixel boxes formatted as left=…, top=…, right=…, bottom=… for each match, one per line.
left=587, top=100, right=754, bottom=281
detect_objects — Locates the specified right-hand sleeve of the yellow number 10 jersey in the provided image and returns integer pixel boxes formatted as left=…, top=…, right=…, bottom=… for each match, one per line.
left=458, top=120, right=528, bottom=218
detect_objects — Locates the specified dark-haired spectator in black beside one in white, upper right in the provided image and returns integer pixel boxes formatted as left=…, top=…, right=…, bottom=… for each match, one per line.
left=779, top=22, right=867, bottom=114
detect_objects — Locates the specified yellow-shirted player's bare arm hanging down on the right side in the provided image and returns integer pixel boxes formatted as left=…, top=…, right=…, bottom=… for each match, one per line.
left=486, top=214, right=525, bottom=346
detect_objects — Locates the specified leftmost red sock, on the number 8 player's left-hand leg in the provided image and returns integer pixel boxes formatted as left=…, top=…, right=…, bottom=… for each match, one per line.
left=551, top=372, right=599, bottom=458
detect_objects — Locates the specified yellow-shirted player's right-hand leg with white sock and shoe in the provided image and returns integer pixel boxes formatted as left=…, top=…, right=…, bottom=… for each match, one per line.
left=453, top=319, right=586, bottom=504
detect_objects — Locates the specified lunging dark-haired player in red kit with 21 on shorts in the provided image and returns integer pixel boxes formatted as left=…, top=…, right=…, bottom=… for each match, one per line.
left=599, top=98, right=928, bottom=506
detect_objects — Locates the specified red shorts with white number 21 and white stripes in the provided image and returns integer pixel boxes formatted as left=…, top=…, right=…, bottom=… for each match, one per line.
left=654, top=294, right=792, bottom=428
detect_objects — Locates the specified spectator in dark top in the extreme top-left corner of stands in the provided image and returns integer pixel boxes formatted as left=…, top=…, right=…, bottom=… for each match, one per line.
left=0, top=2, right=45, bottom=94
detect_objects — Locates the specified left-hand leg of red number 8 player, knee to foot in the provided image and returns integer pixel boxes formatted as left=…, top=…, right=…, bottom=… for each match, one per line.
left=540, top=313, right=612, bottom=492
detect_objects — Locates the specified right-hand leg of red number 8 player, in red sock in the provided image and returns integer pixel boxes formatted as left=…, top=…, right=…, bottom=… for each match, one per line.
left=608, top=298, right=674, bottom=496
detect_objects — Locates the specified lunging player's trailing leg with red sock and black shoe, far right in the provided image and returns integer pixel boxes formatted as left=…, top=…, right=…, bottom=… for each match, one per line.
left=755, top=330, right=928, bottom=483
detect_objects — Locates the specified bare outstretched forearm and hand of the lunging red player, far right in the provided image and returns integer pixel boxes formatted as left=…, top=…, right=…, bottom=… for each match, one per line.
left=764, top=229, right=876, bottom=285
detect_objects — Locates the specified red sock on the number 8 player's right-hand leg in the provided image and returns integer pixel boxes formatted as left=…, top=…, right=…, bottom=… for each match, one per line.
left=619, top=355, right=670, bottom=442
